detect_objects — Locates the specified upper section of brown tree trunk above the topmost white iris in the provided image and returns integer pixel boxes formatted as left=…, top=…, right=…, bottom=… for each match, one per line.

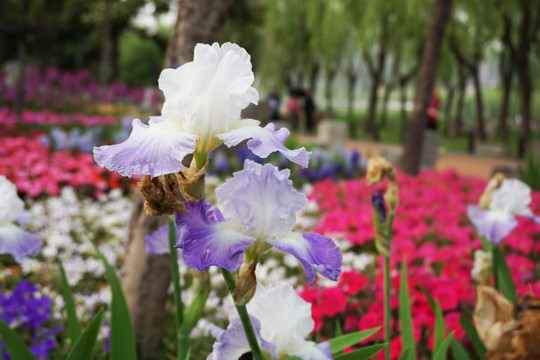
left=165, top=0, right=227, bottom=67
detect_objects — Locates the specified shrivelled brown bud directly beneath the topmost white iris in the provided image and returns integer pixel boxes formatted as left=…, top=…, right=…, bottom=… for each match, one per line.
left=137, top=174, right=187, bottom=216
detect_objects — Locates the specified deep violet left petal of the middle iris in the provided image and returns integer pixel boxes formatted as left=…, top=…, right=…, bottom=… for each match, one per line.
left=175, top=199, right=255, bottom=271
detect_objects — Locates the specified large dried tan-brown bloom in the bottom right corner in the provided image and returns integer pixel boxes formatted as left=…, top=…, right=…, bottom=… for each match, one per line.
left=474, top=286, right=540, bottom=360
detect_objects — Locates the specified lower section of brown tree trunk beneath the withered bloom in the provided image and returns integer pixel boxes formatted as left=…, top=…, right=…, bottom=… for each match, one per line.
left=121, top=196, right=171, bottom=359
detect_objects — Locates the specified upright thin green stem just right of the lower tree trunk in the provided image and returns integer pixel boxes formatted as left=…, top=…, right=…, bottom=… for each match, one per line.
left=168, top=220, right=189, bottom=360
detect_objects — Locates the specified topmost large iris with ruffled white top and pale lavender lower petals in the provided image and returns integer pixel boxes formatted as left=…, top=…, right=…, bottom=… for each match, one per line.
left=94, top=43, right=309, bottom=177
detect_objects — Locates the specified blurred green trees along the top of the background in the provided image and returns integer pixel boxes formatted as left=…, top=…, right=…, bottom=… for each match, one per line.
left=0, top=0, right=540, bottom=153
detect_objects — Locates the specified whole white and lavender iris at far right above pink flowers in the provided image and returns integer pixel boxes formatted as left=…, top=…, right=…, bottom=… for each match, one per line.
left=467, top=179, right=534, bottom=244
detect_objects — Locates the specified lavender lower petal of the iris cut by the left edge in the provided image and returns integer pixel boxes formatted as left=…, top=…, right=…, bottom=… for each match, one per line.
left=0, top=224, right=43, bottom=262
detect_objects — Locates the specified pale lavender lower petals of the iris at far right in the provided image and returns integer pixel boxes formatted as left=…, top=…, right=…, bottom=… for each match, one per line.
left=467, top=205, right=518, bottom=244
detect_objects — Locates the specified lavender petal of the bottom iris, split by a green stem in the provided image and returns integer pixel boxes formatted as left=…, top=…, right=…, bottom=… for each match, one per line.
left=207, top=316, right=279, bottom=360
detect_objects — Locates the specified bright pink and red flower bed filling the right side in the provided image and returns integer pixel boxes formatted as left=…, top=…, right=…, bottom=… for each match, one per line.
left=301, top=171, right=540, bottom=358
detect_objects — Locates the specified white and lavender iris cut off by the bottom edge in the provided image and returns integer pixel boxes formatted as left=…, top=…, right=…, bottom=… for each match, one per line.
left=207, top=282, right=332, bottom=360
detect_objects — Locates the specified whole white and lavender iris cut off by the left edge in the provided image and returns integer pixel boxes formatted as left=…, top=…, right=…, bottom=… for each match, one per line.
left=0, top=175, right=42, bottom=262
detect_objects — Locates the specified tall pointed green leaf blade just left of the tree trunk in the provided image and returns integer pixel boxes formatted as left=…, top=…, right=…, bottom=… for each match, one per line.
left=92, top=242, right=137, bottom=360
